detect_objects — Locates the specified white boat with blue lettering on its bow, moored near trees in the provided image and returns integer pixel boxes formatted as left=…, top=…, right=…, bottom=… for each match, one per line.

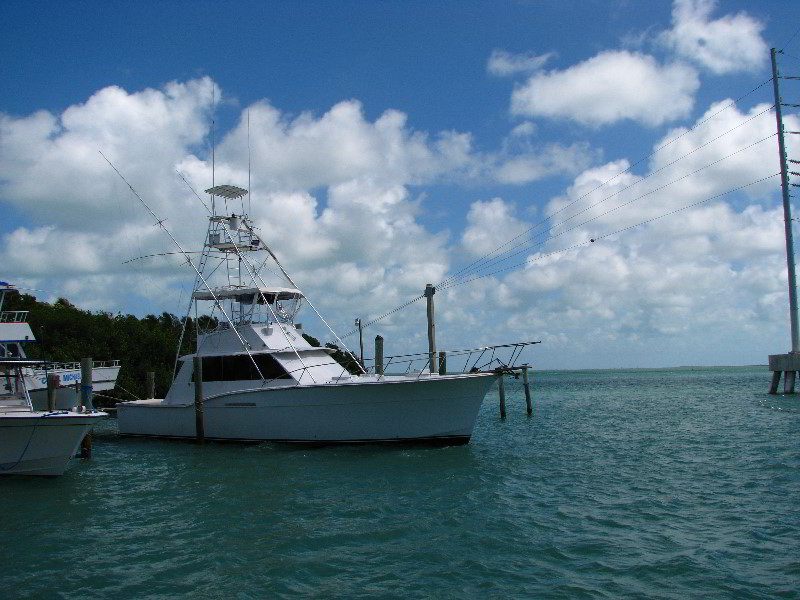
left=0, top=281, right=120, bottom=410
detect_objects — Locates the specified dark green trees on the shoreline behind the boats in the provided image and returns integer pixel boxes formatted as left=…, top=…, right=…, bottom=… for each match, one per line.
left=4, top=293, right=357, bottom=407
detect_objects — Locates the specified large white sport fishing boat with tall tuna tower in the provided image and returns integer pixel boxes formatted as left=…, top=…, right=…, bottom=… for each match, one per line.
left=117, top=185, right=527, bottom=444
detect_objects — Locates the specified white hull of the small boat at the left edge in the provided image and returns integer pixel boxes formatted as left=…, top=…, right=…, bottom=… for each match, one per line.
left=0, top=412, right=107, bottom=475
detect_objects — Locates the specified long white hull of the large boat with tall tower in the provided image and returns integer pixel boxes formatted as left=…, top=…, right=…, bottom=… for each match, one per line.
left=117, top=373, right=495, bottom=444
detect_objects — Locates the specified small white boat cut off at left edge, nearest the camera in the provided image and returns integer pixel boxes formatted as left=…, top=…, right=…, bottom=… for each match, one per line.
left=0, top=359, right=107, bottom=475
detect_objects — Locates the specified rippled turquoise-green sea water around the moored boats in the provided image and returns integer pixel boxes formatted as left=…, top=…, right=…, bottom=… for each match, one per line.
left=0, top=367, right=800, bottom=598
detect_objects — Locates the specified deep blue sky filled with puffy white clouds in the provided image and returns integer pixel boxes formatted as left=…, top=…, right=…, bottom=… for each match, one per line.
left=0, top=0, right=800, bottom=368
